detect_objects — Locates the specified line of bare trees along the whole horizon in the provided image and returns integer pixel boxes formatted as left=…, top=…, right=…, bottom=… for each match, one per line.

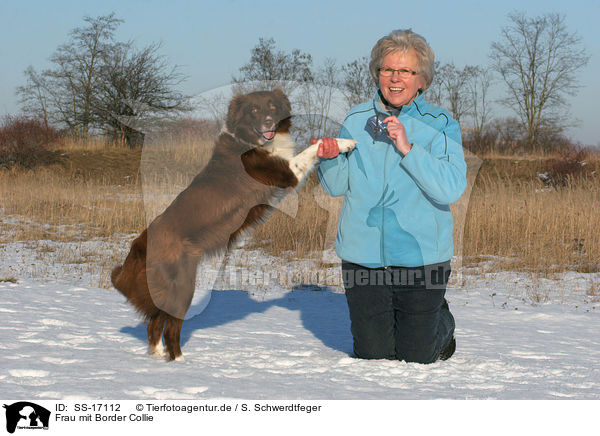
left=17, top=12, right=589, bottom=151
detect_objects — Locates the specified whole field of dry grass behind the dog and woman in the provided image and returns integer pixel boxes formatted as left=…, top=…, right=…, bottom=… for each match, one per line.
left=0, top=138, right=600, bottom=292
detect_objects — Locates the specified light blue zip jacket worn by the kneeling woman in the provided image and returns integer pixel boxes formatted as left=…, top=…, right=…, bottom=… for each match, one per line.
left=318, top=93, right=467, bottom=268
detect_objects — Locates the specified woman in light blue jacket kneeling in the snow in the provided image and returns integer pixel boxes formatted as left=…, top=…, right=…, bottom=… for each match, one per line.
left=318, top=30, right=466, bottom=363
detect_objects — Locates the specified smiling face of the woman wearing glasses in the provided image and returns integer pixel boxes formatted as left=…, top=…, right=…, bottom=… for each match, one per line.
left=379, top=49, right=425, bottom=107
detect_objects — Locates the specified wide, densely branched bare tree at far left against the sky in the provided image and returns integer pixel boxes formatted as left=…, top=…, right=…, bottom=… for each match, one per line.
left=17, top=14, right=187, bottom=146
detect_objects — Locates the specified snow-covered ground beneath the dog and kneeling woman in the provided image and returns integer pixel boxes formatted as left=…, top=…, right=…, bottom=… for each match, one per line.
left=0, top=237, right=600, bottom=400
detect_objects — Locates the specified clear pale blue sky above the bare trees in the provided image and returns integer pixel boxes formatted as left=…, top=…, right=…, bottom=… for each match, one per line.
left=0, top=0, right=600, bottom=145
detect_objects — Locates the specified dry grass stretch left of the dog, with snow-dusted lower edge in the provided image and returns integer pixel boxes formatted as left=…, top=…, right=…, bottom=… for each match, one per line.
left=0, top=138, right=212, bottom=287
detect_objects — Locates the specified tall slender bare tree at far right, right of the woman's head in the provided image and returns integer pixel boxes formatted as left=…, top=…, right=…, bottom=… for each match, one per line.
left=490, top=12, right=589, bottom=147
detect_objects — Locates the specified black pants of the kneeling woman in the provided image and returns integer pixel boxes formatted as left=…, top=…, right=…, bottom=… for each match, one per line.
left=342, top=261, right=455, bottom=363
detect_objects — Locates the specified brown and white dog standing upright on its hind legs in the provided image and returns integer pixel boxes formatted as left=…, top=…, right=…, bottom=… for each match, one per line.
left=111, top=89, right=356, bottom=360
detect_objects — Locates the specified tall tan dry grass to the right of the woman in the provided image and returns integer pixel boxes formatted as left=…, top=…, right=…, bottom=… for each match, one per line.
left=463, top=169, right=600, bottom=274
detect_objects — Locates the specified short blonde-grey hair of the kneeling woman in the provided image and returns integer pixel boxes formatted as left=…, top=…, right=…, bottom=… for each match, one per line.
left=369, top=29, right=434, bottom=89
